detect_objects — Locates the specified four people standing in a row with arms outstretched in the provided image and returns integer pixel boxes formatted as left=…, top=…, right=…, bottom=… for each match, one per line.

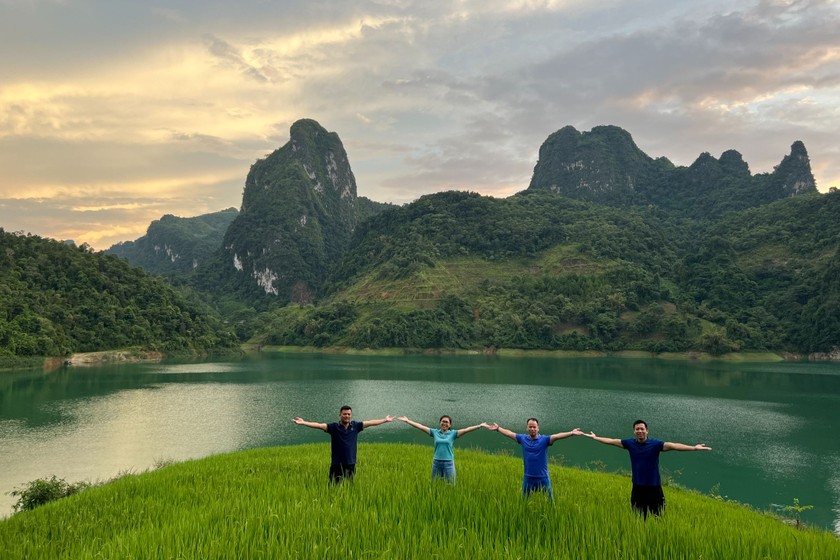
left=293, top=406, right=711, bottom=517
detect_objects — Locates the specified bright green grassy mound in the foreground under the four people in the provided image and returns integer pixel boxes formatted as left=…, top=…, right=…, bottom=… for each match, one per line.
left=0, top=443, right=840, bottom=560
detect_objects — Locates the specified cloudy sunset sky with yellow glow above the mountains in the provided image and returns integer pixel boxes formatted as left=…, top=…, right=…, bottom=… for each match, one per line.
left=0, top=0, right=840, bottom=250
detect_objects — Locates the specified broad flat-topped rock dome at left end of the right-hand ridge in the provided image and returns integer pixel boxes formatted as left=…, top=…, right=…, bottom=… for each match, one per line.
left=528, top=126, right=657, bottom=202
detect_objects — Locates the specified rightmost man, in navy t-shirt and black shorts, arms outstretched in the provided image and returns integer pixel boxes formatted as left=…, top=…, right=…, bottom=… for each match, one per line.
left=584, top=420, right=712, bottom=518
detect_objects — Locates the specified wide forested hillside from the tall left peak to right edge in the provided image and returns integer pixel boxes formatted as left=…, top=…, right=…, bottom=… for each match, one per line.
left=257, top=191, right=840, bottom=354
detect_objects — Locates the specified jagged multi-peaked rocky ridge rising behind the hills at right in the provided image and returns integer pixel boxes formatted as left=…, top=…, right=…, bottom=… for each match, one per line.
left=528, top=126, right=817, bottom=218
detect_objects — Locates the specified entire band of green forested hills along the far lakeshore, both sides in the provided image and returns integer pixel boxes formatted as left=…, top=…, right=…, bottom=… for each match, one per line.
left=6, top=190, right=840, bottom=356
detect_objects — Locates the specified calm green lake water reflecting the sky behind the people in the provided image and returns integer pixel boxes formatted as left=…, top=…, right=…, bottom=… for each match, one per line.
left=0, top=354, right=840, bottom=534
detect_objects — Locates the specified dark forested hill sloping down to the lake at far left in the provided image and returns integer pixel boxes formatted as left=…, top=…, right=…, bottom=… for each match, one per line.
left=0, top=229, right=238, bottom=358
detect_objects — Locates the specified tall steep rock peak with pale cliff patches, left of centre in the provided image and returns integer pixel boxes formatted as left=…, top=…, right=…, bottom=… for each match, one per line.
left=222, top=119, right=359, bottom=303
